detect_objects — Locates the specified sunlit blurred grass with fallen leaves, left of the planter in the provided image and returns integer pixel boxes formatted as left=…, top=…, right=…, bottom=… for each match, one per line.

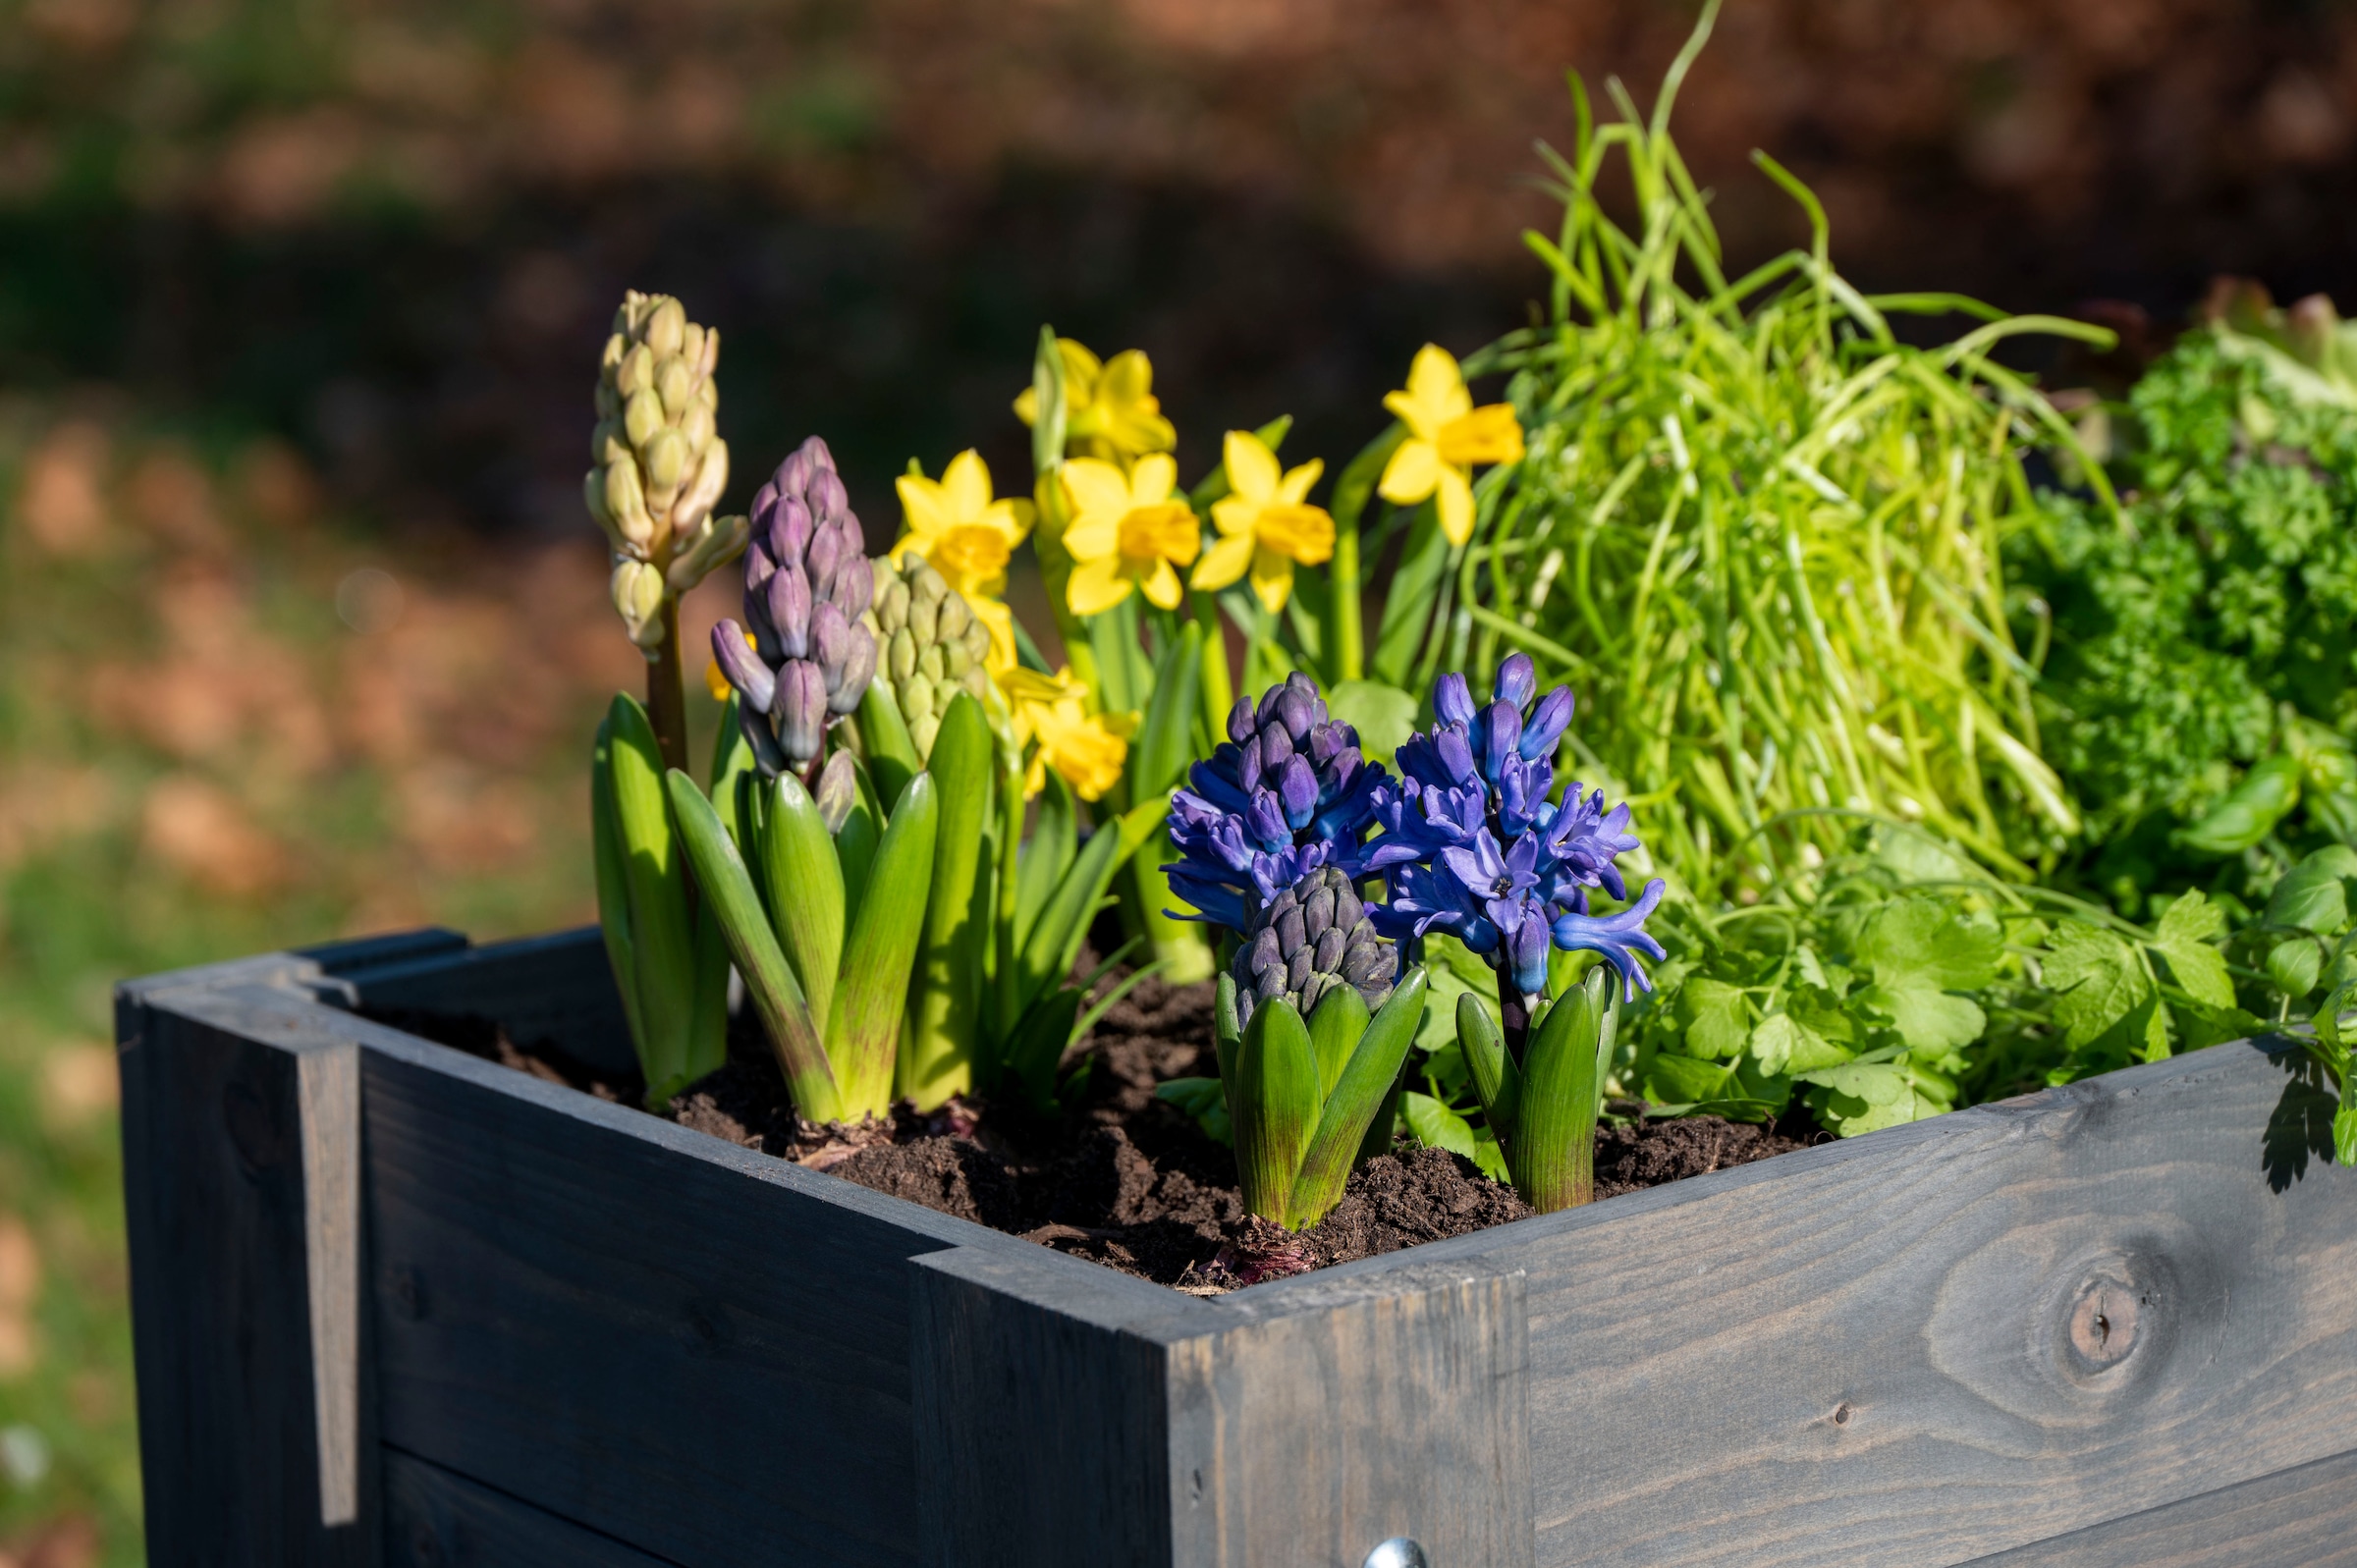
left=0, top=404, right=660, bottom=1568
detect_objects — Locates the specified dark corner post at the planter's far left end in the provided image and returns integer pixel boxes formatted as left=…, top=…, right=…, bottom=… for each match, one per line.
left=116, top=962, right=377, bottom=1568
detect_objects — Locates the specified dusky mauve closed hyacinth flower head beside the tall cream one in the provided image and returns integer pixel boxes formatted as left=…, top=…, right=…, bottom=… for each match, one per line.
left=712, top=436, right=877, bottom=781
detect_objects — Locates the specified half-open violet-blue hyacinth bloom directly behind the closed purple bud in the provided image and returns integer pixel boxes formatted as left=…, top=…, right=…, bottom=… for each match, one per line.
left=1162, top=675, right=1386, bottom=936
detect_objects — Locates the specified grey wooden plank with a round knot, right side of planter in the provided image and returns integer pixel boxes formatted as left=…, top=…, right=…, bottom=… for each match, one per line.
left=1282, top=1045, right=2357, bottom=1568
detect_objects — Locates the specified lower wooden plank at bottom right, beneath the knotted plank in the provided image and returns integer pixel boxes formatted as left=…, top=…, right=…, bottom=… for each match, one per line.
left=1970, top=1455, right=2357, bottom=1568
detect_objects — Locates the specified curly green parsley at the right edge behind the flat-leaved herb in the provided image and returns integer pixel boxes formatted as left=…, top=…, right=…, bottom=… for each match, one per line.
left=2013, top=330, right=2357, bottom=915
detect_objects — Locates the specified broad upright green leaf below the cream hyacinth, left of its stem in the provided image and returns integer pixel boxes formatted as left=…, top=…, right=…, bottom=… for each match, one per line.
left=606, top=695, right=695, bottom=1087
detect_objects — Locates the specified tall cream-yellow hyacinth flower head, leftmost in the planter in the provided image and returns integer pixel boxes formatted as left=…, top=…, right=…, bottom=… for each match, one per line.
left=582, top=290, right=744, bottom=648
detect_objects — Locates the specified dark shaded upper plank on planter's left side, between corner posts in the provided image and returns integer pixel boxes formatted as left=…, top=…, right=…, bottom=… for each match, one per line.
left=347, top=1018, right=1096, bottom=1568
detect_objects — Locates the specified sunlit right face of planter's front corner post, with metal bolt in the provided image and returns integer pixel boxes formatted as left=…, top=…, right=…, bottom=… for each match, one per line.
left=1169, top=1255, right=1534, bottom=1568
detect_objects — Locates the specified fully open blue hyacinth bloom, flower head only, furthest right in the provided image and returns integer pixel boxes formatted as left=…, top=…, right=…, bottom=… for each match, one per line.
left=1365, top=653, right=1664, bottom=998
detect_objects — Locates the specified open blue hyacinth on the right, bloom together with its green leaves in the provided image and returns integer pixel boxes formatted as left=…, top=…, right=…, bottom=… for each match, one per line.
left=1365, top=653, right=1664, bottom=1212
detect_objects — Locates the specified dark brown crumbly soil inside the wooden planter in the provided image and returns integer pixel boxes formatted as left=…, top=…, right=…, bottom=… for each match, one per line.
left=375, top=979, right=1825, bottom=1294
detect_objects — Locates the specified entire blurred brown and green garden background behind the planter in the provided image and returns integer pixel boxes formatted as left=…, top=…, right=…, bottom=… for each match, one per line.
left=0, top=0, right=2357, bottom=1568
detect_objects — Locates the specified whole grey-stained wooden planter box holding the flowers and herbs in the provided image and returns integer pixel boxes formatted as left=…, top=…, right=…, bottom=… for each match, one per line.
left=118, top=932, right=2357, bottom=1568
